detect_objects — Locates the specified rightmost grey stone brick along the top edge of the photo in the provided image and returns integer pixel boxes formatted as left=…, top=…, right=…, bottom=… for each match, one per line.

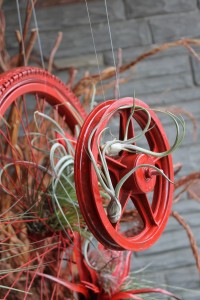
left=125, top=0, right=197, bottom=18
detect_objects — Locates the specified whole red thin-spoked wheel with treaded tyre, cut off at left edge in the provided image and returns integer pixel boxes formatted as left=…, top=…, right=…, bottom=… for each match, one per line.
left=0, top=67, right=86, bottom=237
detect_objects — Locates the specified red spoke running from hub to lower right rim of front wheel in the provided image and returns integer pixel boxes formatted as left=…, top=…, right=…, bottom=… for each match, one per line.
left=131, top=194, right=158, bottom=226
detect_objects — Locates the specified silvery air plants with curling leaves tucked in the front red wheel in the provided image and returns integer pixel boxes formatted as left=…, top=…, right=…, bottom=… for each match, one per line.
left=88, top=99, right=185, bottom=223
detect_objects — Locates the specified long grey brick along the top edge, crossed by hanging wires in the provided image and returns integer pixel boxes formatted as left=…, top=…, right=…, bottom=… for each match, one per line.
left=3, top=0, right=125, bottom=30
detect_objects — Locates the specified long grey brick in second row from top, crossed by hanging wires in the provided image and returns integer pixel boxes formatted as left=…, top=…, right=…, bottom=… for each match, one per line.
left=31, top=20, right=151, bottom=57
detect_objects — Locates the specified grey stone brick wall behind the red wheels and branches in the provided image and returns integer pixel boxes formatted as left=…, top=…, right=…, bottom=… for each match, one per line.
left=4, top=0, right=200, bottom=300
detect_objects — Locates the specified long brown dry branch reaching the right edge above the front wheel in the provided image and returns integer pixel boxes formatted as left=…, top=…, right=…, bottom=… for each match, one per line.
left=73, top=39, right=200, bottom=96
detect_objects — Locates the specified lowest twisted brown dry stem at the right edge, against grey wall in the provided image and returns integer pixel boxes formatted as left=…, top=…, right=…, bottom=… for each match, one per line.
left=171, top=211, right=200, bottom=272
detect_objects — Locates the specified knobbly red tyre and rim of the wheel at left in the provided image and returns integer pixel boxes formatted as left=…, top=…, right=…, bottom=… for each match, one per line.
left=0, top=67, right=87, bottom=126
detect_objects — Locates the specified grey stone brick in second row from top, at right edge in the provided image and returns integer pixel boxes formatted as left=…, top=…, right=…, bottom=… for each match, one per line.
left=149, top=12, right=200, bottom=43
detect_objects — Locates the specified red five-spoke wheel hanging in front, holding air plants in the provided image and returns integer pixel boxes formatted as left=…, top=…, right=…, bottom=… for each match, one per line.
left=75, top=98, right=173, bottom=251
